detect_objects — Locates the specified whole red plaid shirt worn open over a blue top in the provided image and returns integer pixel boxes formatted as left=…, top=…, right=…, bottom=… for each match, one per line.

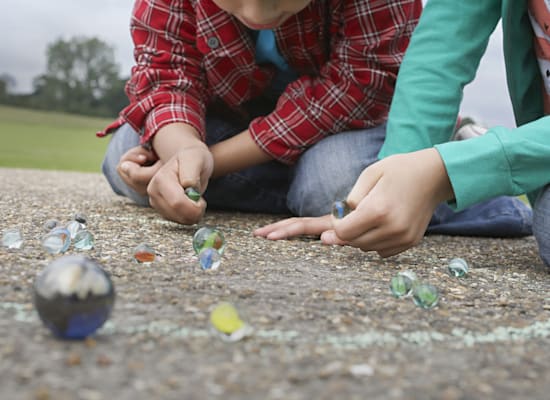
left=98, top=0, right=422, bottom=163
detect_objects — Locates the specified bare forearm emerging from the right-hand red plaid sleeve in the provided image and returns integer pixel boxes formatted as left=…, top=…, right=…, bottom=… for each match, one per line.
left=210, top=130, right=272, bottom=178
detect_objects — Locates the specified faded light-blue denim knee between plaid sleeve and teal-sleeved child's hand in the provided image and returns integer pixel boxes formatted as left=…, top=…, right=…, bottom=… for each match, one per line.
left=287, top=124, right=386, bottom=217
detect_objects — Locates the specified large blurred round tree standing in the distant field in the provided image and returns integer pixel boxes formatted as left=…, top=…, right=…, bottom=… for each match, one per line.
left=33, top=37, right=120, bottom=115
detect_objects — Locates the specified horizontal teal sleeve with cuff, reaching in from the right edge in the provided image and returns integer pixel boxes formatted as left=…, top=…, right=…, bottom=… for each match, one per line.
left=435, top=117, right=550, bottom=209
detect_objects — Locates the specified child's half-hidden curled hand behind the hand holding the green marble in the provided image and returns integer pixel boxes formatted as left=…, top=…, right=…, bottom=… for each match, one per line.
left=117, top=146, right=162, bottom=196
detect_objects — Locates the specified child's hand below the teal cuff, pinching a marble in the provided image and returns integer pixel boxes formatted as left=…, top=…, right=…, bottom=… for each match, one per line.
left=321, top=149, right=454, bottom=257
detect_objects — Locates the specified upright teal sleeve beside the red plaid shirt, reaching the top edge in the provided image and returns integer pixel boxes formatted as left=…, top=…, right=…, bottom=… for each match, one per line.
left=379, top=0, right=505, bottom=158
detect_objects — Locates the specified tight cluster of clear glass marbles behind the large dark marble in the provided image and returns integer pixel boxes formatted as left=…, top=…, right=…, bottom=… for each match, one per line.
left=42, top=213, right=95, bottom=254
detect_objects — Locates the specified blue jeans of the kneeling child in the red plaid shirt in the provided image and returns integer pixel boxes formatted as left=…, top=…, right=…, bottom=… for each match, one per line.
left=102, top=116, right=536, bottom=237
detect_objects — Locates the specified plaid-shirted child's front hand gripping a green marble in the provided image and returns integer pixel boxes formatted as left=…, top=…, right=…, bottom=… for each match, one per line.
left=147, top=143, right=214, bottom=224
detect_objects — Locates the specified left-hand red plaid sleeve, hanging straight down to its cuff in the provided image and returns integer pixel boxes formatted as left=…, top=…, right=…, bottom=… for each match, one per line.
left=115, top=0, right=205, bottom=143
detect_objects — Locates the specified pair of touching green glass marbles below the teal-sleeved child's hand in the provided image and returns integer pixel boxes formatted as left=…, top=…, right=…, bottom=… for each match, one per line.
left=390, top=271, right=439, bottom=309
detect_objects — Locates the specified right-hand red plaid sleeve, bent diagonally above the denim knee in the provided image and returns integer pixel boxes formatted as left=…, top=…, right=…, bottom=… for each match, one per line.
left=249, top=0, right=422, bottom=164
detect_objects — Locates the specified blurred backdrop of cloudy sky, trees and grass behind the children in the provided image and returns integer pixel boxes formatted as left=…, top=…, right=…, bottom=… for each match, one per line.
left=0, top=0, right=514, bottom=171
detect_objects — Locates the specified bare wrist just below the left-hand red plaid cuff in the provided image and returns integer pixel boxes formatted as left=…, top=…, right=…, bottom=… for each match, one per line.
left=152, top=123, right=206, bottom=162
